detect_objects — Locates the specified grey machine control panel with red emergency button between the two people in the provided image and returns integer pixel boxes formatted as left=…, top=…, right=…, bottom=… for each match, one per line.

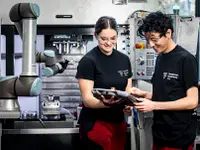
left=128, top=11, right=157, bottom=80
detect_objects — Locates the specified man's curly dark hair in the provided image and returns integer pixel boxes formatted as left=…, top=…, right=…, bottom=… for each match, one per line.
left=137, top=11, right=174, bottom=37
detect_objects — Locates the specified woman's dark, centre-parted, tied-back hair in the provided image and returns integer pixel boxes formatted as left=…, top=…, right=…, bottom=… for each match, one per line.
left=95, top=16, right=118, bottom=35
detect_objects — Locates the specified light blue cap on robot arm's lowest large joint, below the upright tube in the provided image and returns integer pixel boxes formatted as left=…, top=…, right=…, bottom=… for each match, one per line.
left=30, top=78, right=42, bottom=96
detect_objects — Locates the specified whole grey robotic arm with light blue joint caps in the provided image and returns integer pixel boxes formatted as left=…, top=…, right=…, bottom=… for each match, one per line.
left=0, top=3, right=68, bottom=119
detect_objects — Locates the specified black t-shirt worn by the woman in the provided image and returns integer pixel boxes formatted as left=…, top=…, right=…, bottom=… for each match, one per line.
left=76, top=47, right=132, bottom=127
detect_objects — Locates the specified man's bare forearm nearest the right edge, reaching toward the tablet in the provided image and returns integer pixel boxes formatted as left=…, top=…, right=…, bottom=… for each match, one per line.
left=154, top=97, right=198, bottom=110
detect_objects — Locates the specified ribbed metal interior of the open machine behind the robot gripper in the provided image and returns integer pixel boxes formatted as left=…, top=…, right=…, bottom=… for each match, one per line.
left=40, top=34, right=93, bottom=118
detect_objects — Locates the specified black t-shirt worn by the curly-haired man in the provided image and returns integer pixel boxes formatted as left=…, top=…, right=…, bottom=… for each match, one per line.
left=152, top=45, right=198, bottom=148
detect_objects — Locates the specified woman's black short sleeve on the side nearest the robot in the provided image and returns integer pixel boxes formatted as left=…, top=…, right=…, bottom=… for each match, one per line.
left=76, top=57, right=95, bottom=80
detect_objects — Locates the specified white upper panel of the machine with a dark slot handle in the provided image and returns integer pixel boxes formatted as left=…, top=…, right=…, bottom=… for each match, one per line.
left=0, top=0, right=158, bottom=24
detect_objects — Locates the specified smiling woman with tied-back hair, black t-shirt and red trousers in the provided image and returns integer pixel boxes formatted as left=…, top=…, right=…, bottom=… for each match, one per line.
left=76, top=16, right=132, bottom=150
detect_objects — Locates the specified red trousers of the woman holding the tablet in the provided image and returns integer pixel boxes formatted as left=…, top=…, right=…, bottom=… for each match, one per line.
left=87, top=120, right=126, bottom=150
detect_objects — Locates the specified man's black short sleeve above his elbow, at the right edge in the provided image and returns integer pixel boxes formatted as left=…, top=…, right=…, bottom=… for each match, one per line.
left=183, top=55, right=198, bottom=90
